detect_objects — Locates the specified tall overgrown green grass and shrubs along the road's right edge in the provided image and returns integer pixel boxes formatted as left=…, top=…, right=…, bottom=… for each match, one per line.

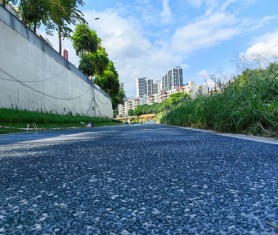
left=161, top=64, right=278, bottom=137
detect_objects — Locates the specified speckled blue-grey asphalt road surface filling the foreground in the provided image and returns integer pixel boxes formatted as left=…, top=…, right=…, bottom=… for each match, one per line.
left=0, top=124, right=278, bottom=235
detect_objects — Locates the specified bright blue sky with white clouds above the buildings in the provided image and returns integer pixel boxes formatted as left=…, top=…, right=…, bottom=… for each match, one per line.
left=39, top=0, right=278, bottom=97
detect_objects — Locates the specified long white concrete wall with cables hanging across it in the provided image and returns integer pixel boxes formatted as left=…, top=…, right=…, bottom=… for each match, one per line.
left=0, top=6, right=113, bottom=118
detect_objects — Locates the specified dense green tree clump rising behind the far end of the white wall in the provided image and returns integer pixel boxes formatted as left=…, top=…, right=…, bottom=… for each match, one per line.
left=72, top=24, right=125, bottom=110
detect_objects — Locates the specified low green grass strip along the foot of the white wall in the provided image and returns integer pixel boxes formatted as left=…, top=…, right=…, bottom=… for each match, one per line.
left=0, top=109, right=121, bottom=134
